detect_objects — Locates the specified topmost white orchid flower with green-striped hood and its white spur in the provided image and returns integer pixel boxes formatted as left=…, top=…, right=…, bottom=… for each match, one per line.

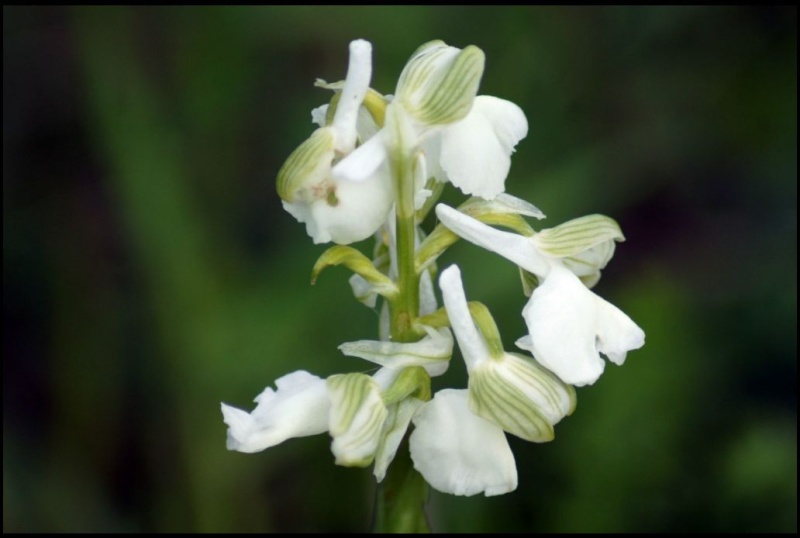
left=333, top=41, right=528, bottom=205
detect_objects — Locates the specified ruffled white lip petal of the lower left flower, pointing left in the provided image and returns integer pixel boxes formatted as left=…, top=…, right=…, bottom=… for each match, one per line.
left=222, top=370, right=330, bottom=453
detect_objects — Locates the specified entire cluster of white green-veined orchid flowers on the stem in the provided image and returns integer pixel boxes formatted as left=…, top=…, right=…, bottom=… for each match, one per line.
left=222, top=40, right=644, bottom=495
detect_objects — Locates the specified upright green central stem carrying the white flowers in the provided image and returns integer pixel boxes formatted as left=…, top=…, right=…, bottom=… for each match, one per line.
left=374, top=105, right=429, bottom=533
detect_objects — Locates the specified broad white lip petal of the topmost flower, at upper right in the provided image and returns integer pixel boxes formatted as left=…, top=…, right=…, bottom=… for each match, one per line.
left=439, top=96, right=528, bottom=199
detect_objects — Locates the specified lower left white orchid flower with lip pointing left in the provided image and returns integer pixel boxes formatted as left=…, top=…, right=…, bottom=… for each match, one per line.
left=222, top=327, right=453, bottom=472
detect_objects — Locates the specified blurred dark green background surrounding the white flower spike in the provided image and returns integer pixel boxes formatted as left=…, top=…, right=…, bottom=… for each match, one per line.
left=3, top=7, right=797, bottom=532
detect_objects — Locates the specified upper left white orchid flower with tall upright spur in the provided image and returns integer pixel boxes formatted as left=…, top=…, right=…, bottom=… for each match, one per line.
left=277, top=40, right=394, bottom=244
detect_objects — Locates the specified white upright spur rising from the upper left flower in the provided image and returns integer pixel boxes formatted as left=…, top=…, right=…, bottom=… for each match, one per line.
left=332, top=39, right=372, bottom=153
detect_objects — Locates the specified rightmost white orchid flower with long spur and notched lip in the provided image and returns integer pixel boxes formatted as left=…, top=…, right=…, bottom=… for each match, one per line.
left=436, top=204, right=644, bottom=386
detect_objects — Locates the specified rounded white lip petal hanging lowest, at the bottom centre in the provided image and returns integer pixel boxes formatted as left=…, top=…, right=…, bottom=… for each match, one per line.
left=409, top=389, right=517, bottom=496
